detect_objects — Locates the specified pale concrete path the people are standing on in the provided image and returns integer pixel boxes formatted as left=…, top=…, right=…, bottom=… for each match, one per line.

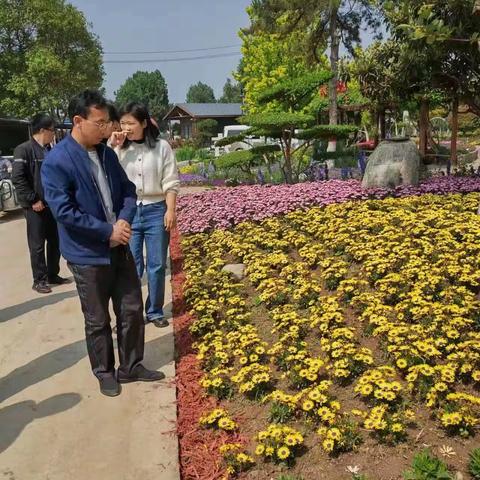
left=0, top=212, right=179, bottom=480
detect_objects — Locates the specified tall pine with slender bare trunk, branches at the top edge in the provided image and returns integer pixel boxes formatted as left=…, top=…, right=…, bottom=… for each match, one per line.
left=248, top=0, right=380, bottom=149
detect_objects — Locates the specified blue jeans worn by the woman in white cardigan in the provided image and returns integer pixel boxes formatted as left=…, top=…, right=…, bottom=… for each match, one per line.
left=130, top=202, right=170, bottom=322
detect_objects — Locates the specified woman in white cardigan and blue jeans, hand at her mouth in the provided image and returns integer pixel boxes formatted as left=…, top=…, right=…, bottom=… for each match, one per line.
left=111, top=102, right=180, bottom=327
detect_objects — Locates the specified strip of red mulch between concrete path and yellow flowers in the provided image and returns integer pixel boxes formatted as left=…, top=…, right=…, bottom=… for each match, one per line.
left=170, top=230, right=244, bottom=480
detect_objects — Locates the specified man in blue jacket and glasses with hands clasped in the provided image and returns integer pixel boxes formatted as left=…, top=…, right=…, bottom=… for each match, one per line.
left=41, top=90, right=165, bottom=396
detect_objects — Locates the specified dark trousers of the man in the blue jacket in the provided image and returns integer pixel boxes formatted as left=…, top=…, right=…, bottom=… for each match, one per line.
left=68, top=246, right=145, bottom=378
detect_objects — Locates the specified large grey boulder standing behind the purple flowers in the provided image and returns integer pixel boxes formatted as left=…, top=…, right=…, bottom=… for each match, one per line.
left=362, top=138, right=420, bottom=188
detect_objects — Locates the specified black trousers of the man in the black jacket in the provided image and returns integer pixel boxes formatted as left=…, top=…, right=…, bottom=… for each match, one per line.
left=23, top=208, right=60, bottom=283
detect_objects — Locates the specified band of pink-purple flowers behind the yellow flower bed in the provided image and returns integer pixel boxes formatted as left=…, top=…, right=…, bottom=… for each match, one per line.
left=178, top=175, right=480, bottom=233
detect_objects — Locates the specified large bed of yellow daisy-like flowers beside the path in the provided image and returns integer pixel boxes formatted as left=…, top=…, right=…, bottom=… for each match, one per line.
left=186, top=193, right=480, bottom=461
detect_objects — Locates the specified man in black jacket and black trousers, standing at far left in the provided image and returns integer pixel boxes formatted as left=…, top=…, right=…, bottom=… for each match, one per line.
left=12, top=114, right=69, bottom=293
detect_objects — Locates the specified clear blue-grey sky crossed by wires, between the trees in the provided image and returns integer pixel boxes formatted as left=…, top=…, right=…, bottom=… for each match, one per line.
left=70, top=0, right=250, bottom=103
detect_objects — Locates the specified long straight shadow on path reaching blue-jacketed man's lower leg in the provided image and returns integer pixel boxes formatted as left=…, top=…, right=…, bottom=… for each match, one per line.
left=0, top=339, right=87, bottom=402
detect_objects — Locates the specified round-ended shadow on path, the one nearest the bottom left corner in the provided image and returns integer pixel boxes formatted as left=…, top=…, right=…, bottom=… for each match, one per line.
left=0, top=393, right=82, bottom=454
